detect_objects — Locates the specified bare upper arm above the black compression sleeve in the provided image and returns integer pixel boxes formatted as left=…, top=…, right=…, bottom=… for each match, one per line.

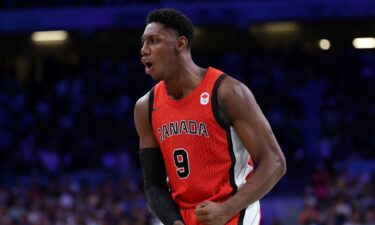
left=134, top=94, right=158, bottom=148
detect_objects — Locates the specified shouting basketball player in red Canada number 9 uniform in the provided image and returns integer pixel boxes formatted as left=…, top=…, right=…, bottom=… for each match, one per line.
left=134, top=9, right=286, bottom=225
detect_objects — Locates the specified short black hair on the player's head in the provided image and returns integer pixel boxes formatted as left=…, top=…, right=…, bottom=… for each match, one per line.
left=146, top=8, right=194, bottom=48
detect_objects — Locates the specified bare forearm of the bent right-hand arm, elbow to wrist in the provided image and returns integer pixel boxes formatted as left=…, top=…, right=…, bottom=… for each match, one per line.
left=223, top=156, right=286, bottom=218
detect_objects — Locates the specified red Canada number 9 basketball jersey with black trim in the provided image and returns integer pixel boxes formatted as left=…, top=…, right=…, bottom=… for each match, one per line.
left=149, top=67, right=253, bottom=209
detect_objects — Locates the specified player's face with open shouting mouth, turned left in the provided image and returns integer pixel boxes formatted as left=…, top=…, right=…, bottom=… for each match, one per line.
left=141, top=22, right=178, bottom=80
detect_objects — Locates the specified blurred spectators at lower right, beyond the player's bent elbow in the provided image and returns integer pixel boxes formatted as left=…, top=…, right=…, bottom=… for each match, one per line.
left=298, top=164, right=375, bottom=225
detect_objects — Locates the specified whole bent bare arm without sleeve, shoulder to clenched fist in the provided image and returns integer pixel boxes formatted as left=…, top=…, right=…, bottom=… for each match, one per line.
left=196, top=77, right=286, bottom=224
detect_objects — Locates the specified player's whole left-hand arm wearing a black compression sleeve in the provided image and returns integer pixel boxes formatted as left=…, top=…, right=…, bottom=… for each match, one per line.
left=134, top=94, right=183, bottom=225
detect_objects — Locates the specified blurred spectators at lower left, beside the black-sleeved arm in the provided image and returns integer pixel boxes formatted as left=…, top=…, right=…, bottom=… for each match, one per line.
left=0, top=173, right=153, bottom=225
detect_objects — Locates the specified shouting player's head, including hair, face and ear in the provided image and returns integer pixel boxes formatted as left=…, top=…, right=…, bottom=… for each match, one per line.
left=141, top=8, right=194, bottom=79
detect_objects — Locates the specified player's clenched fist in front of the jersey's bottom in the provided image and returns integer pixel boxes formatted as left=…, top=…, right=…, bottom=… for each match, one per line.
left=195, top=201, right=230, bottom=225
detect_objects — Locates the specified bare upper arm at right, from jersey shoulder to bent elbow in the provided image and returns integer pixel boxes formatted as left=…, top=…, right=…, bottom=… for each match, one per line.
left=218, top=78, right=281, bottom=162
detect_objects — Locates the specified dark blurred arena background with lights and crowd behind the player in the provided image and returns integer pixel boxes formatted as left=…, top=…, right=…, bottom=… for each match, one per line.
left=0, top=0, right=375, bottom=225
